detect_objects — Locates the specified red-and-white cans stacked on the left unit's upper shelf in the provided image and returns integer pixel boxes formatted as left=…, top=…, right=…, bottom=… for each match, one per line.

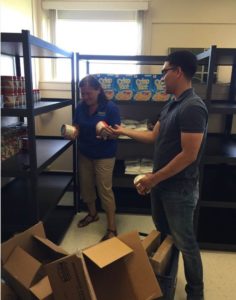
left=1, top=76, right=40, bottom=107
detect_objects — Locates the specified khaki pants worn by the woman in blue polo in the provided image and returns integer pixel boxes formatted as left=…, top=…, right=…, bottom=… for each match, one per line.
left=79, top=153, right=116, bottom=212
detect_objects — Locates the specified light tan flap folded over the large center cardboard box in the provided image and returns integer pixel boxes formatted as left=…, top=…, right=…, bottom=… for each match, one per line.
left=83, top=237, right=133, bottom=268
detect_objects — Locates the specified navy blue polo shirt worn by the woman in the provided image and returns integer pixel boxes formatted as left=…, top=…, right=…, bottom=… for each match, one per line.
left=74, top=100, right=120, bottom=159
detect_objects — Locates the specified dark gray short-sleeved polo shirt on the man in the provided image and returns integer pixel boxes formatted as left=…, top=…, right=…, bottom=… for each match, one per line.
left=153, top=88, right=208, bottom=188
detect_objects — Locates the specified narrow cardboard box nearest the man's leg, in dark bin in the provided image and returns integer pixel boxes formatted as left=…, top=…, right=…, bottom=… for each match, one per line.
left=149, top=236, right=174, bottom=275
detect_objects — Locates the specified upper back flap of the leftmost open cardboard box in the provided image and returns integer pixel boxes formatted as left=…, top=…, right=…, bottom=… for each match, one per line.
left=1, top=222, right=46, bottom=264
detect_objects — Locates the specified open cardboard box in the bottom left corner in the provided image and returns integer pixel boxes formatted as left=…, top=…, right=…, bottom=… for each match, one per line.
left=1, top=222, right=67, bottom=300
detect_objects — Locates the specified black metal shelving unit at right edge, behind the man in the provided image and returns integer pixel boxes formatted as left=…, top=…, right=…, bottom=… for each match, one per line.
left=197, top=46, right=236, bottom=251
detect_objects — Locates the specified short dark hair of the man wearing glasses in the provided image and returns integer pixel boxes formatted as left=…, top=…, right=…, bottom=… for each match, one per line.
left=166, top=50, right=197, bottom=79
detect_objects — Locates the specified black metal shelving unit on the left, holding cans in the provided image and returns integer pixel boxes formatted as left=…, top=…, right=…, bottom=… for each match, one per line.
left=1, top=30, right=77, bottom=242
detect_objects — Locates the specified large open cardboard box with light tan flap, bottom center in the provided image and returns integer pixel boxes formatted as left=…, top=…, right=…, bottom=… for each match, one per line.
left=46, top=232, right=162, bottom=300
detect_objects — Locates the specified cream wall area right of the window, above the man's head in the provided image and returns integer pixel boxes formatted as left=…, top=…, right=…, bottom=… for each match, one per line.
left=149, top=0, right=236, bottom=55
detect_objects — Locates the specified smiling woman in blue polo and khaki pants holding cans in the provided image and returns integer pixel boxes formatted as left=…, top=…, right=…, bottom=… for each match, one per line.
left=74, top=75, right=120, bottom=240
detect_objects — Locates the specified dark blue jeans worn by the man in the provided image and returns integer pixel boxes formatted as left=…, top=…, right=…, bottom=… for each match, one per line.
left=151, top=185, right=203, bottom=298
